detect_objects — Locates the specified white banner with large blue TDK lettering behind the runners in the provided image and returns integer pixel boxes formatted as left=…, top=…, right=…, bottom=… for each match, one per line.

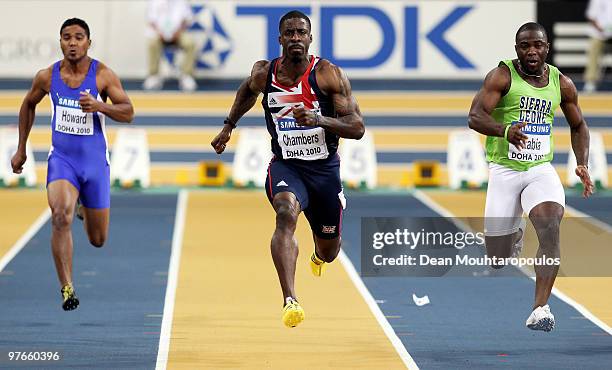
left=186, top=0, right=536, bottom=78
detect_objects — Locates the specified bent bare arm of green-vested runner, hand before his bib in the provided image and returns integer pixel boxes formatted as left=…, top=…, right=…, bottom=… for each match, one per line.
left=468, top=66, right=527, bottom=149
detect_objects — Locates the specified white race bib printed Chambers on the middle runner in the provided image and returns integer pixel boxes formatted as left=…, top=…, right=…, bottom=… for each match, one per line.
left=276, top=117, right=329, bottom=161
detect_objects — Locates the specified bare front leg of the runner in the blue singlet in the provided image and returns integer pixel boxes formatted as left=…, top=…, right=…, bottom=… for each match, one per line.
left=47, top=180, right=79, bottom=287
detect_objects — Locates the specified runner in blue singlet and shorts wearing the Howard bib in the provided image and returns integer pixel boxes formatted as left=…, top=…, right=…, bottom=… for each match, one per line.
left=11, top=18, right=134, bottom=311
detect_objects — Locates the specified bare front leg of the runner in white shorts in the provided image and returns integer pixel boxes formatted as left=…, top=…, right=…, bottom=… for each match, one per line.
left=529, top=202, right=563, bottom=309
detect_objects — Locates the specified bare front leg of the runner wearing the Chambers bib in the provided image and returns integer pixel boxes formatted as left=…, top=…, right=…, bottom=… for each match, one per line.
left=270, top=192, right=301, bottom=304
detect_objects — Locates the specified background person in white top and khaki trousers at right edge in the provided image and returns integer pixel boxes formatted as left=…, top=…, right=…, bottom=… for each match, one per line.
left=583, top=0, right=612, bottom=92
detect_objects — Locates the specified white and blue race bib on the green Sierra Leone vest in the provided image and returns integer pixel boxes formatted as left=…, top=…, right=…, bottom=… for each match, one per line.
left=508, top=122, right=551, bottom=162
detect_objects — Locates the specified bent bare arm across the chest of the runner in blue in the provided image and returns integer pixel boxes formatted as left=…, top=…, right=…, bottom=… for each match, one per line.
left=79, top=63, right=134, bottom=123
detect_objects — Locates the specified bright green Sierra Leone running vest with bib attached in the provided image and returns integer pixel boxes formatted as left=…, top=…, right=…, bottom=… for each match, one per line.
left=485, top=60, right=561, bottom=171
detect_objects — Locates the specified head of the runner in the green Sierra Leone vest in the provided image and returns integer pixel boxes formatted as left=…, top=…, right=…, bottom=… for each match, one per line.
left=514, top=30, right=550, bottom=74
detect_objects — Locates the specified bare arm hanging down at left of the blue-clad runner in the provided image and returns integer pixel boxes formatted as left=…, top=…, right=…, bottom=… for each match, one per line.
left=11, top=67, right=52, bottom=173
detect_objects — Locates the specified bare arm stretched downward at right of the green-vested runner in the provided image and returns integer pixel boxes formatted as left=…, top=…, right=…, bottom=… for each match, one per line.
left=559, top=75, right=594, bottom=198
